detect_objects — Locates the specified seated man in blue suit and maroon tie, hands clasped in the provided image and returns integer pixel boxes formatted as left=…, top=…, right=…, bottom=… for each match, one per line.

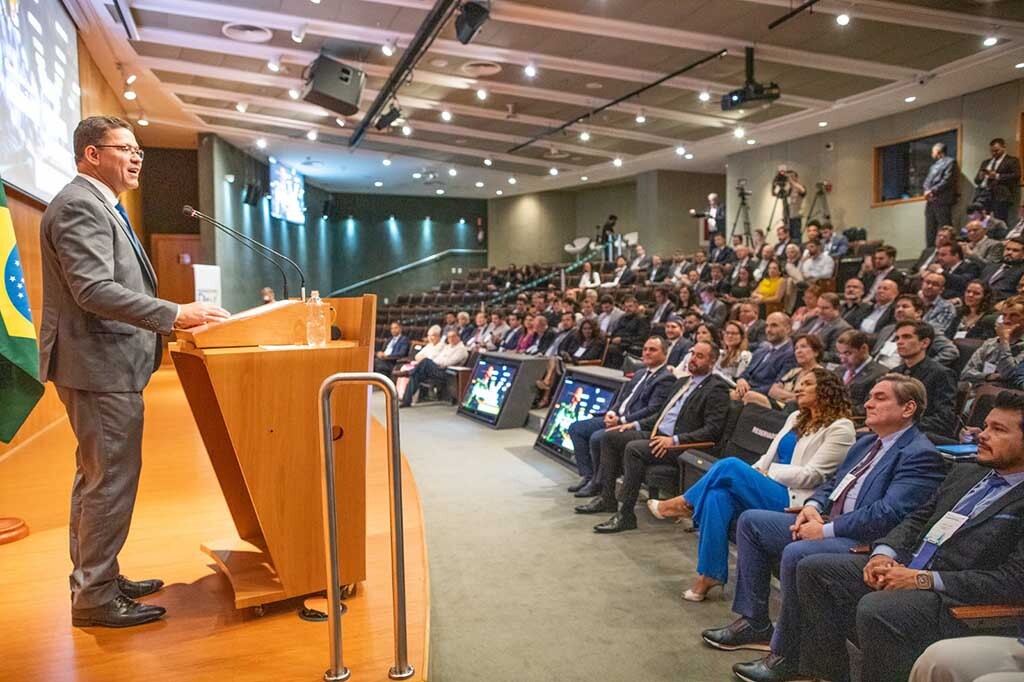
left=703, top=375, right=945, bottom=682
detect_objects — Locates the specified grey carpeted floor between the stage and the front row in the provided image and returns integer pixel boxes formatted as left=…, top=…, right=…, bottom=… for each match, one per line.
left=374, top=394, right=763, bottom=682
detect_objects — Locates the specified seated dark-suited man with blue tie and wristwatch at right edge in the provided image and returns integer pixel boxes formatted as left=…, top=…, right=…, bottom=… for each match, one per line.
left=797, top=393, right=1024, bottom=682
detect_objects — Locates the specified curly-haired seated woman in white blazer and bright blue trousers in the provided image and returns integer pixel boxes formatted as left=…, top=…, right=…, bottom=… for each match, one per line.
left=647, top=368, right=855, bottom=601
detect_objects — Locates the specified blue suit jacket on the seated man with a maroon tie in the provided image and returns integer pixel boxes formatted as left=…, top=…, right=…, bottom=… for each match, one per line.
left=808, top=426, right=946, bottom=543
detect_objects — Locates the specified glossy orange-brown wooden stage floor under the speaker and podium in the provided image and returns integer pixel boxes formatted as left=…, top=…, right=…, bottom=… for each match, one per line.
left=0, top=369, right=430, bottom=682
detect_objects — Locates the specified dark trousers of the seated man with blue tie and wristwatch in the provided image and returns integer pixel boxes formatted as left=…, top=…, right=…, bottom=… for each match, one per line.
left=797, top=554, right=964, bottom=682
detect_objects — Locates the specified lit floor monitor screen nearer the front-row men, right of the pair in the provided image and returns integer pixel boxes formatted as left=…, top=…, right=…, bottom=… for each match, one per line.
left=537, top=371, right=622, bottom=458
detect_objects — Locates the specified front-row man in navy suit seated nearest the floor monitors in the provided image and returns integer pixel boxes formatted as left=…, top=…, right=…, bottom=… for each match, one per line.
left=569, top=336, right=674, bottom=491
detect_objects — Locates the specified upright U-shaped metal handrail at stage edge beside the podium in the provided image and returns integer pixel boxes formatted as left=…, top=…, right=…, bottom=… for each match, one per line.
left=319, top=372, right=415, bottom=682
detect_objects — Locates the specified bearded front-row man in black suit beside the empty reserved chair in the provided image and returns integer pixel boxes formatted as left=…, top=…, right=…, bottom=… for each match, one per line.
left=575, top=341, right=729, bottom=532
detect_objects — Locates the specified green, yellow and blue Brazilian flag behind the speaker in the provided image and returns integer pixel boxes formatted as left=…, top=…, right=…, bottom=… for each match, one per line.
left=0, top=176, right=43, bottom=442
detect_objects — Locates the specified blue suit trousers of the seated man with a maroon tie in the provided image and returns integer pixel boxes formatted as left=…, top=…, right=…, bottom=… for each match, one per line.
left=732, top=509, right=857, bottom=662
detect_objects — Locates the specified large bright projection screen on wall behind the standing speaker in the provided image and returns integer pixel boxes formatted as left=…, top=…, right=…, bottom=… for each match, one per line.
left=0, top=0, right=82, bottom=202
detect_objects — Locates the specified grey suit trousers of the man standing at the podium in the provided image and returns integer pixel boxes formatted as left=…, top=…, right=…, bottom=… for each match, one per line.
left=57, top=386, right=142, bottom=608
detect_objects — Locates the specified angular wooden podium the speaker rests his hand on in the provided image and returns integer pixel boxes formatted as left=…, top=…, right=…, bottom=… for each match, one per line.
left=170, top=296, right=377, bottom=608
